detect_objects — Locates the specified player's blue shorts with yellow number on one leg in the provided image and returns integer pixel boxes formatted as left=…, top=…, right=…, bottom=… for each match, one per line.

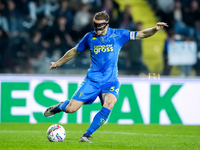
left=72, top=77, right=119, bottom=105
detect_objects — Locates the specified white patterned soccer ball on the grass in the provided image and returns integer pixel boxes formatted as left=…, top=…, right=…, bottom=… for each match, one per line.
left=47, top=124, right=66, bottom=142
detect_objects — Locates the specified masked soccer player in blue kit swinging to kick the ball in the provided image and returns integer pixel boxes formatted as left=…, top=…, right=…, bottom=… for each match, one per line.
left=44, top=11, right=168, bottom=143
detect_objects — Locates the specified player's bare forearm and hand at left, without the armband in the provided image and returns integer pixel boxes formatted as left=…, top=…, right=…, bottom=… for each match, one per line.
left=49, top=47, right=79, bottom=70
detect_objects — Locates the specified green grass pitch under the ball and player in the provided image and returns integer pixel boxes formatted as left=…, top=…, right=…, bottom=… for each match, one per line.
left=0, top=123, right=200, bottom=150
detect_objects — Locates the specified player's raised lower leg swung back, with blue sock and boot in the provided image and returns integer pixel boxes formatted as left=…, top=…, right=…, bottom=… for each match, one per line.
left=44, top=99, right=83, bottom=117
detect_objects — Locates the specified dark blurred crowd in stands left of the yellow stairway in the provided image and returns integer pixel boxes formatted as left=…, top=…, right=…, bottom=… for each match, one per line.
left=0, top=0, right=142, bottom=74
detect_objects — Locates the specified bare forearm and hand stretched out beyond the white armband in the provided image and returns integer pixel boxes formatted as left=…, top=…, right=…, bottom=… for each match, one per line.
left=136, top=22, right=168, bottom=39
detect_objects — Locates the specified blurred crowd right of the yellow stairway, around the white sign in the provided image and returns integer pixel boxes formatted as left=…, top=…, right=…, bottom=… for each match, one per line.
left=149, top=0, right=200, bottom=76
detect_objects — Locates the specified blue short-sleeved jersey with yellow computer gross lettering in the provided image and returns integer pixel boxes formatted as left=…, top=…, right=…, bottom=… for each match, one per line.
left=77, top=27, right=137, bottom=83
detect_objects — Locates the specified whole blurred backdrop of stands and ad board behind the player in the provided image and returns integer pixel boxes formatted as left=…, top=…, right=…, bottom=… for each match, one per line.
left=0, top=0, right=200, bottom=125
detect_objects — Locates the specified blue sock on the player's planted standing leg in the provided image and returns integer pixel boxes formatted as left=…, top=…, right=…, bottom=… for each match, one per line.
left=85, top=107, right=111, bottom=136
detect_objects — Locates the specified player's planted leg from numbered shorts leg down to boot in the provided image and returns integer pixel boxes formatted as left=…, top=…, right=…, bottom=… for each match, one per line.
left=79, top=82, right=119, bottom=142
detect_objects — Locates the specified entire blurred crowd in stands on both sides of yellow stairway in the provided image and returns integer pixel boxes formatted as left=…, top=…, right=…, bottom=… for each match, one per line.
left=0, top=0, right=200, bottom=75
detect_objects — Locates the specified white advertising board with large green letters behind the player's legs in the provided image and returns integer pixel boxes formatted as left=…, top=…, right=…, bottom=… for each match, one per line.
left=0, top=76, right=200, bottom=125
